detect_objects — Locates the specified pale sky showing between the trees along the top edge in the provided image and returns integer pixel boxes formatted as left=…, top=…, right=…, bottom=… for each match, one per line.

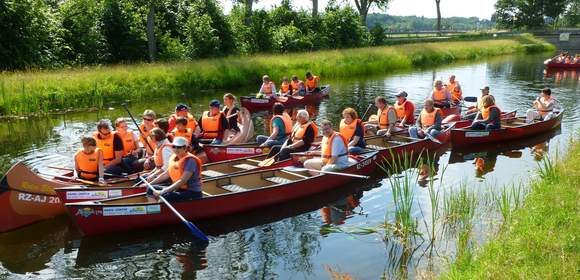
left=219, top=0, right=496, bottom=19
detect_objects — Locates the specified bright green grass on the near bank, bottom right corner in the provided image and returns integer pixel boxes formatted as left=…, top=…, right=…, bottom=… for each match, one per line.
left=443, top=141, right=580, bottom=279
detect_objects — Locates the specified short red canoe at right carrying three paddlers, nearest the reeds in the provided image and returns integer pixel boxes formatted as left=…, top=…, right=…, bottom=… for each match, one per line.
left=451, top=111, right=564, bottom=148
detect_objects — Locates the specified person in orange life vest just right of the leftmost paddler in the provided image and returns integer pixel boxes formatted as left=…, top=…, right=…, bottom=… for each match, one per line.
left=93, top=119, right=124, bottom=175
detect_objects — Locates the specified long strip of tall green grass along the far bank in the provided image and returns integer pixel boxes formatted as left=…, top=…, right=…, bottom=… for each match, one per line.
left=0, top=36, right=554, bottom=116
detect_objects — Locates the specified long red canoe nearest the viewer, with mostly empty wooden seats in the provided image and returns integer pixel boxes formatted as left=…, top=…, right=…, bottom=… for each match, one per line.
left=65, top=152, right=377, bottom=235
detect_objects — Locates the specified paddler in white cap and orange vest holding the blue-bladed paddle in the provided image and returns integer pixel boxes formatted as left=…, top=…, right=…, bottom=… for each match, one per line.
left=147, top=137, right=202, bottom=201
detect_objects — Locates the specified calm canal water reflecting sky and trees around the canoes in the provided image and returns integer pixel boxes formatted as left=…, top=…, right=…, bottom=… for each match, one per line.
left=0, top=54, right=580, bottom=279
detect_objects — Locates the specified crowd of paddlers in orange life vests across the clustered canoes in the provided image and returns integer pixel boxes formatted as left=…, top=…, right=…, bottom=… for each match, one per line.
left=75, top=73, right=554, bottom=200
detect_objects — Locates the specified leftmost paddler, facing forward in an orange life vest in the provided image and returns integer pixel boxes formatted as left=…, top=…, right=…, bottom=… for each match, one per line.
left=73, top=137, right=105, bottom=183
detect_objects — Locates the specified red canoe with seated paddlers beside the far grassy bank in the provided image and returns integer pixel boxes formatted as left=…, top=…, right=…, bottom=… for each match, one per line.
left=240, top=85, right=330, bottom=112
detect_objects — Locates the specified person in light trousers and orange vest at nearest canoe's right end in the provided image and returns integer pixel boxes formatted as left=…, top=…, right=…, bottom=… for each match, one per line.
left=304, top=120, right=349, bottom=175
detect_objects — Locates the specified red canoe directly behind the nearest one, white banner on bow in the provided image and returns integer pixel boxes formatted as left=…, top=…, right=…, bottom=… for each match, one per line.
left=55, top=154, right=292, bottom=204
